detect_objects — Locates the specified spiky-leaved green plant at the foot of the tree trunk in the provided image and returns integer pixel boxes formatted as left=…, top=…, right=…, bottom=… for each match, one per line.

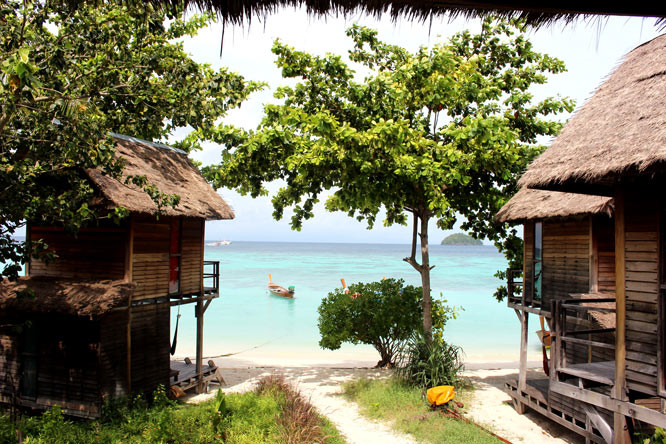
left=398, top=332, right=463, bottom=389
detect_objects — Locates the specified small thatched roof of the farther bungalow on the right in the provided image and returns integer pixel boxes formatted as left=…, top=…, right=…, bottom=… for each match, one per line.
left=495, top=188, right=613, bottom=222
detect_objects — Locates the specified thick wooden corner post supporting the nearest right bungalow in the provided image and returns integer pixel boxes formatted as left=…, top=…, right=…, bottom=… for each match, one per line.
left=613, top=189, right=631, bottom=444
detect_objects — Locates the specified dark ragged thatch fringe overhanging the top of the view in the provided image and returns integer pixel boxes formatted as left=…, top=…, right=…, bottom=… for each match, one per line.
left=151, top=0, right=666, bottom=26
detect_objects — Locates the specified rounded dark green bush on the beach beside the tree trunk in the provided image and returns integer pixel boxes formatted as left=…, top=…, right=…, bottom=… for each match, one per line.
left=318, top=279, right=456, bottom=367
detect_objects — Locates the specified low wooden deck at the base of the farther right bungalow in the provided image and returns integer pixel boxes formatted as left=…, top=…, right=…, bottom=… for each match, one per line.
left=504, top=378, right=606, bottom=444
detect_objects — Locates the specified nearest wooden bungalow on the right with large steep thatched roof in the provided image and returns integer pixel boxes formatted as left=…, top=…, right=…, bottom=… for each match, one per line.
left=504, top=35, right=666, bottom=444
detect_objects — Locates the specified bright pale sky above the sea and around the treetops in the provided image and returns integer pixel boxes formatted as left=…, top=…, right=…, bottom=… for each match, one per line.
left=175, top=8, right=659, bottom=244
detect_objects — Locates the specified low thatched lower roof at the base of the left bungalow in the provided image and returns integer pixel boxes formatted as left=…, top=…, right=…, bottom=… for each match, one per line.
left=0, top=276, right=136, bottom=316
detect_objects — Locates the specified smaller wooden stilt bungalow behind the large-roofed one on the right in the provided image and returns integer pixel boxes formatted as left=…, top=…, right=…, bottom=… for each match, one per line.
left=496, top=188, right=615, bottom=442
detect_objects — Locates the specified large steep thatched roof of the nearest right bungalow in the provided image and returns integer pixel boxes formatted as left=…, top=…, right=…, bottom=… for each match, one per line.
left=519, top=34, right=666, bottom=194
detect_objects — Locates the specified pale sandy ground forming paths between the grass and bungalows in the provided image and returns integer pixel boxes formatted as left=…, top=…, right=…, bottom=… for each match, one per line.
left=182, top=358, right=584, bottom=444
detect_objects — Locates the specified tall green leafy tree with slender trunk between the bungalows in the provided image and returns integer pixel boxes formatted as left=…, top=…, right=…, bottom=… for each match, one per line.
left=205, top=19, right=573, bottom=337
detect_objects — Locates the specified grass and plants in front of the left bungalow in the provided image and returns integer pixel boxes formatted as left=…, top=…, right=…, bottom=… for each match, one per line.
left=0, top=380, right=345, bottom=444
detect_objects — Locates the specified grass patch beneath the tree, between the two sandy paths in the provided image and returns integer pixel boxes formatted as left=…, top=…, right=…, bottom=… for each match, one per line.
left=343, top=378, right=501, bottom=444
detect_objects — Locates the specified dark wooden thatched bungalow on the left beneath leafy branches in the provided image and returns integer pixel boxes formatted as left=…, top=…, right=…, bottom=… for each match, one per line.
left=0, top=135, right=234, bottom=417
